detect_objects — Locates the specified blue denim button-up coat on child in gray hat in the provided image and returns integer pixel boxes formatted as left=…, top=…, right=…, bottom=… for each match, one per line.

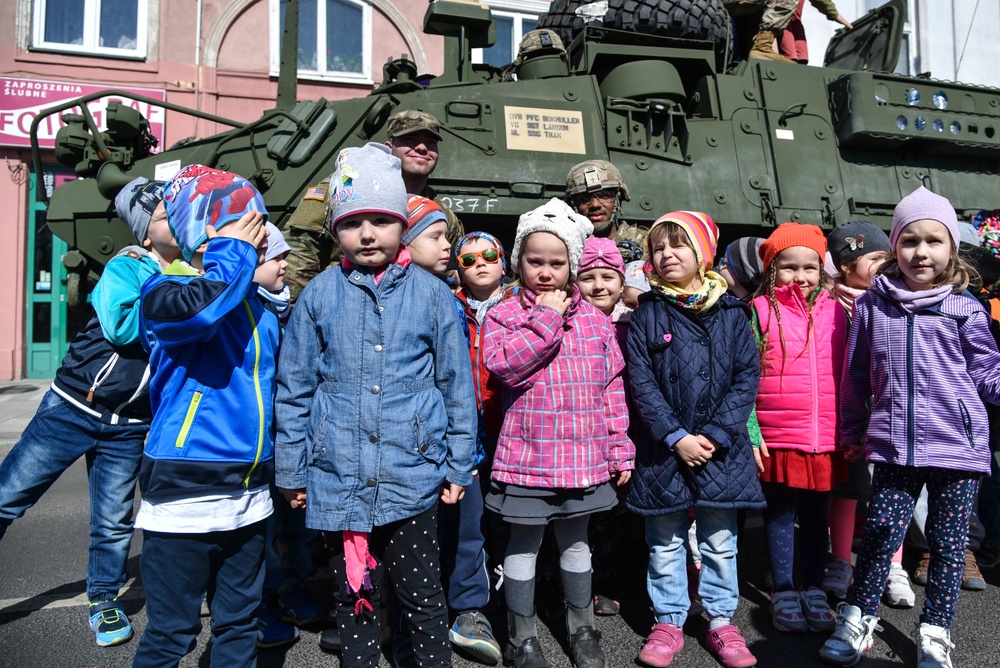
left=275, top=264, right=476, bottom=531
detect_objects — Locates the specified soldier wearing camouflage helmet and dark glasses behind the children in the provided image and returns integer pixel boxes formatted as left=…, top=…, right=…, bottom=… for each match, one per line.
left=566, top=160, right=649, bottom=247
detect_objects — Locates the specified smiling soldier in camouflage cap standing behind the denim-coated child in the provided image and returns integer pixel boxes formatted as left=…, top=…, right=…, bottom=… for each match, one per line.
left=284, top=110, right=465, bottom=303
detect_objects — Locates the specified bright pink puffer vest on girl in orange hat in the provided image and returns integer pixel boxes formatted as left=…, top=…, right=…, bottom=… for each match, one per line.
left=753, top=285, right=847, bottom=453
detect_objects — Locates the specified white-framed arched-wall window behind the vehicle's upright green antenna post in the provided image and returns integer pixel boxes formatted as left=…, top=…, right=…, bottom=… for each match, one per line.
left=270, top=0, right=372, bottom=83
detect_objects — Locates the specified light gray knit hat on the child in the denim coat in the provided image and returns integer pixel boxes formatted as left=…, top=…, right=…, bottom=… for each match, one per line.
left=327, top=142, right=407, bottom=232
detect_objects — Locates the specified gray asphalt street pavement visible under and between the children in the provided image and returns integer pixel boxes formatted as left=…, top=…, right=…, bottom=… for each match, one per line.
left=0, top=381, right=1000, bottom=668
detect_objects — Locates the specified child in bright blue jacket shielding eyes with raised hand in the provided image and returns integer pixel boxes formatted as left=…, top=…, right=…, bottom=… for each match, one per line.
left=133, top=165, right=278, bottom=668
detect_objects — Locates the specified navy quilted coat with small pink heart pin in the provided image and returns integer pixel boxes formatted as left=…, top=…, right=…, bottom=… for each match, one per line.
left=628, top=291, right=765, bottom=515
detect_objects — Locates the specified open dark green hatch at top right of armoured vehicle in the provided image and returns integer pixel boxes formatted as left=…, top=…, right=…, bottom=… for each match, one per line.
left=823, top=0, right=906, bottom=72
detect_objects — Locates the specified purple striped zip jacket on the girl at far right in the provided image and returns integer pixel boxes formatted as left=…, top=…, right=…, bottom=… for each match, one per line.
left=840, top=276, right=1000, bottom=473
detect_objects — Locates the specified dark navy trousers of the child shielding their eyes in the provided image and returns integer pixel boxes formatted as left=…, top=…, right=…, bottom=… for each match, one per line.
left=132, top=520, right=267, bottom=668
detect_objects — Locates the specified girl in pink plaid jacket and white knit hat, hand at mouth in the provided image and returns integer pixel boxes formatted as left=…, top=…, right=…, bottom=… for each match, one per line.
left=483, top=199, right=635, bottom=668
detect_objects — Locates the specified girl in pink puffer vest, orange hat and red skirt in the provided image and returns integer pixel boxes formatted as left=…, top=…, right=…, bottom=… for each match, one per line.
left=752, top=223, right=847, bottom=633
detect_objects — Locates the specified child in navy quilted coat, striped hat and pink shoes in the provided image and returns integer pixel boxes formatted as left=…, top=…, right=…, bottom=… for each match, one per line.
left=628, top=211, right=764, bottom=667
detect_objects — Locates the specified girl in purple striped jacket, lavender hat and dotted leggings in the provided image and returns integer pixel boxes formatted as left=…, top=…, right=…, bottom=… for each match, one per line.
left=819, top=187, right=1000, bottom=668
